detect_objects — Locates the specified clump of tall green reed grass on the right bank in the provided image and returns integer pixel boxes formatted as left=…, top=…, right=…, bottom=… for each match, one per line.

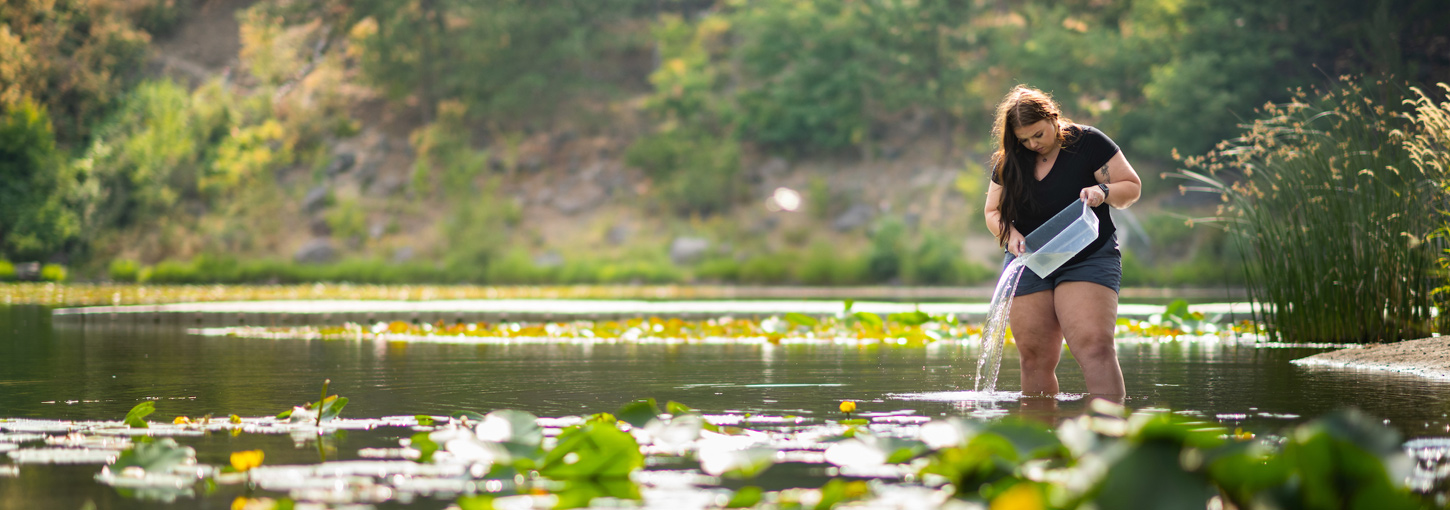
left=1170, top=80, right=1447, bottom=343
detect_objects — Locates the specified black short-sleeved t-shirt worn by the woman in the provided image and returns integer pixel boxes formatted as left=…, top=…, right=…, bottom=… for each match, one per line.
left=992, top=125, right=1118, bottom=265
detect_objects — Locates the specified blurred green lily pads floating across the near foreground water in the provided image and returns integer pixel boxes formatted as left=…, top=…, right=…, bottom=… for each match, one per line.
left=0, top=391, right=1450, bottom=509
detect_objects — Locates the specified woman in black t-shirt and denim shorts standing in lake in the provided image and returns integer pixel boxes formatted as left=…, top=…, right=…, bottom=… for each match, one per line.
left=986, top=85, right=1143, bottom=401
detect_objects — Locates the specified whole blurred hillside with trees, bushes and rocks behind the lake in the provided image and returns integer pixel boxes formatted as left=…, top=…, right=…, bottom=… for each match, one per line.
left=0, top=0, right=1450, bottom=285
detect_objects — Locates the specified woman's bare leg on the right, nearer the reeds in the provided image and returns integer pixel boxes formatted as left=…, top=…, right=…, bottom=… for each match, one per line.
left=1054, top=281, right=1125, bottom=401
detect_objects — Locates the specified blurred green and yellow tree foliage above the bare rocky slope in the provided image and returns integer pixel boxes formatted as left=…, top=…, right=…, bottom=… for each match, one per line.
left=0, top=0, right=1450, bottom=270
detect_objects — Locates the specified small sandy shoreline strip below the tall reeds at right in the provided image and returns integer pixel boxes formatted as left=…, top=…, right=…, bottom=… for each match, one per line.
left=1293, top=336, right=1450, bottom=380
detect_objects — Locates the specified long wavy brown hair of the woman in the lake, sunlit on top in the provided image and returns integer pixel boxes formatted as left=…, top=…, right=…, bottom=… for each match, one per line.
left=992, top=85, right=1073, bottom=246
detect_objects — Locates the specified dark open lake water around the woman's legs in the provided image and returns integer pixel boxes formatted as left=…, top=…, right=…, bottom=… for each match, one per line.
left=8, top=306, right=1450, bottom=509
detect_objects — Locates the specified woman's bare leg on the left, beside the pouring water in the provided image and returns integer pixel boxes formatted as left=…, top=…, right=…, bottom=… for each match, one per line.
left=1008, top=290, right=1063, bottom=396
